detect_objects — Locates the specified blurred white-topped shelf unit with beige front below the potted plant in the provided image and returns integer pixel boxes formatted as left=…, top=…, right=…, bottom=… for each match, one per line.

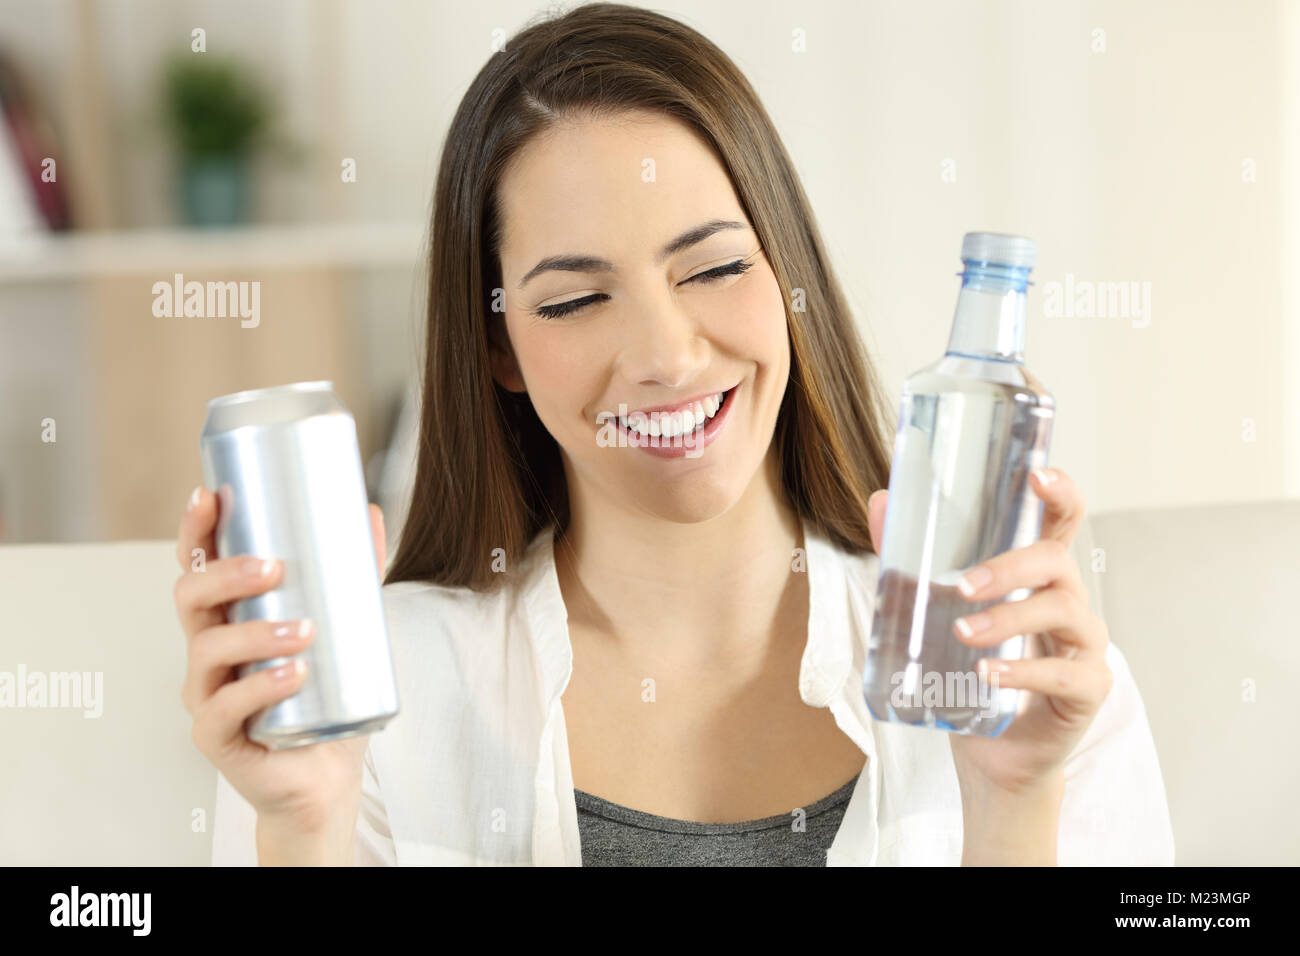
left=0, top=222, right=426, bottom=541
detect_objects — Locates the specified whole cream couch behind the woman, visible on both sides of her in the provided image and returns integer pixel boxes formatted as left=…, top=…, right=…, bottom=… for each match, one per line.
left=0, top=501, right=1300, bottom=866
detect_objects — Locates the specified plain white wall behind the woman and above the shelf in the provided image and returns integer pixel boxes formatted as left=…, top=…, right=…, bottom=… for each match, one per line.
left=0, top=0, right=1300, bottom=510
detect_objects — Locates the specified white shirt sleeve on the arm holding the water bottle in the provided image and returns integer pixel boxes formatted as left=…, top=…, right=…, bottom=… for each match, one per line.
left=1057, top=644, right=1174, bottom=866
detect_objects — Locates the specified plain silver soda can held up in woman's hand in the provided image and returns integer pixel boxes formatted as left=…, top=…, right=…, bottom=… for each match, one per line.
left=199, top=381, right=398, bottom=749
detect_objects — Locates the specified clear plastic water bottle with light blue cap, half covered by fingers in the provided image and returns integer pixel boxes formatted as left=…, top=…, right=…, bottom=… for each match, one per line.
left=863, top=233, right=1056, bottom=736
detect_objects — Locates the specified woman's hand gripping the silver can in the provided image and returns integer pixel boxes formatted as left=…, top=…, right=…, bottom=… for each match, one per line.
left=173, top=486, right=385, bottom=858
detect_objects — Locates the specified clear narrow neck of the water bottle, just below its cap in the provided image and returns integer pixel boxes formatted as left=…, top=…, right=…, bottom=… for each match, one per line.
left=948, top=259, right=1030, bottom=364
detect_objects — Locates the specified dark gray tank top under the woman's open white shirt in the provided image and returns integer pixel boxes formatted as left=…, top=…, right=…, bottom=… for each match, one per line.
left=573, top=777, right=858, bottom=866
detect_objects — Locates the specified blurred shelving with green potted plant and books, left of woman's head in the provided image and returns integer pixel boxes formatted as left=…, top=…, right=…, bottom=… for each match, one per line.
left=0, top=0, right=439, bottom=542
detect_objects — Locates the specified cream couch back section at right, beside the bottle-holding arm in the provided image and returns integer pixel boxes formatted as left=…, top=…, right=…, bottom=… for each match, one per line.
left=1082, top=501, right=1300, bottom=865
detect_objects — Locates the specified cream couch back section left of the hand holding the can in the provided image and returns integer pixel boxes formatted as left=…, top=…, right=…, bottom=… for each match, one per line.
left=0, top=541, right=217, bottom=866
